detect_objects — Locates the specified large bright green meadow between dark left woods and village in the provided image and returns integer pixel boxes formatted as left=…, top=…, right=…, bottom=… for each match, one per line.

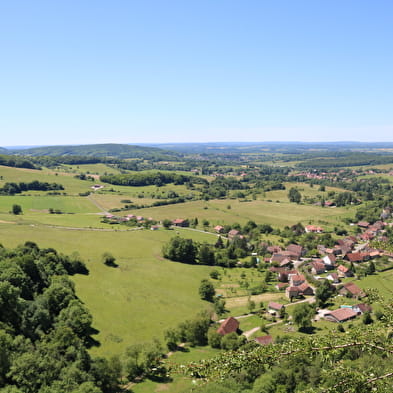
left=0, top=223, right=215, bottom=355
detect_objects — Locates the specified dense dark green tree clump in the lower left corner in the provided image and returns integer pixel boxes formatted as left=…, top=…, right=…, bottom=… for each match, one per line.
left=0, top=242, right=120, bottom=393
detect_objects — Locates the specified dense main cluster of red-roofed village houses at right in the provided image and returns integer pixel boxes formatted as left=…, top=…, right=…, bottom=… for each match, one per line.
left=215, top=217, right=393, bottom=345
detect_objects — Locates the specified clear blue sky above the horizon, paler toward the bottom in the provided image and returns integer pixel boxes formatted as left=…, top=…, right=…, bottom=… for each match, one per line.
left=0, top=0, right=393, bottom=146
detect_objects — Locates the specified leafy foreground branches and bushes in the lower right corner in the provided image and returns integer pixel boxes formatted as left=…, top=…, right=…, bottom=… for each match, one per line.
left=176, top=290, right=393, bottom=393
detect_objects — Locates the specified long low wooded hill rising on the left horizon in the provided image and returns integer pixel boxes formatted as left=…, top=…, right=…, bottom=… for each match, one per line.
left=12, top=143, right=179, bottom=160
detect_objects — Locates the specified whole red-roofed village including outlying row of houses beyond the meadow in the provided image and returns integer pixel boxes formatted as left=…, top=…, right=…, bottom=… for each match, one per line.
left=99, top=202, right=393, bottom=345
